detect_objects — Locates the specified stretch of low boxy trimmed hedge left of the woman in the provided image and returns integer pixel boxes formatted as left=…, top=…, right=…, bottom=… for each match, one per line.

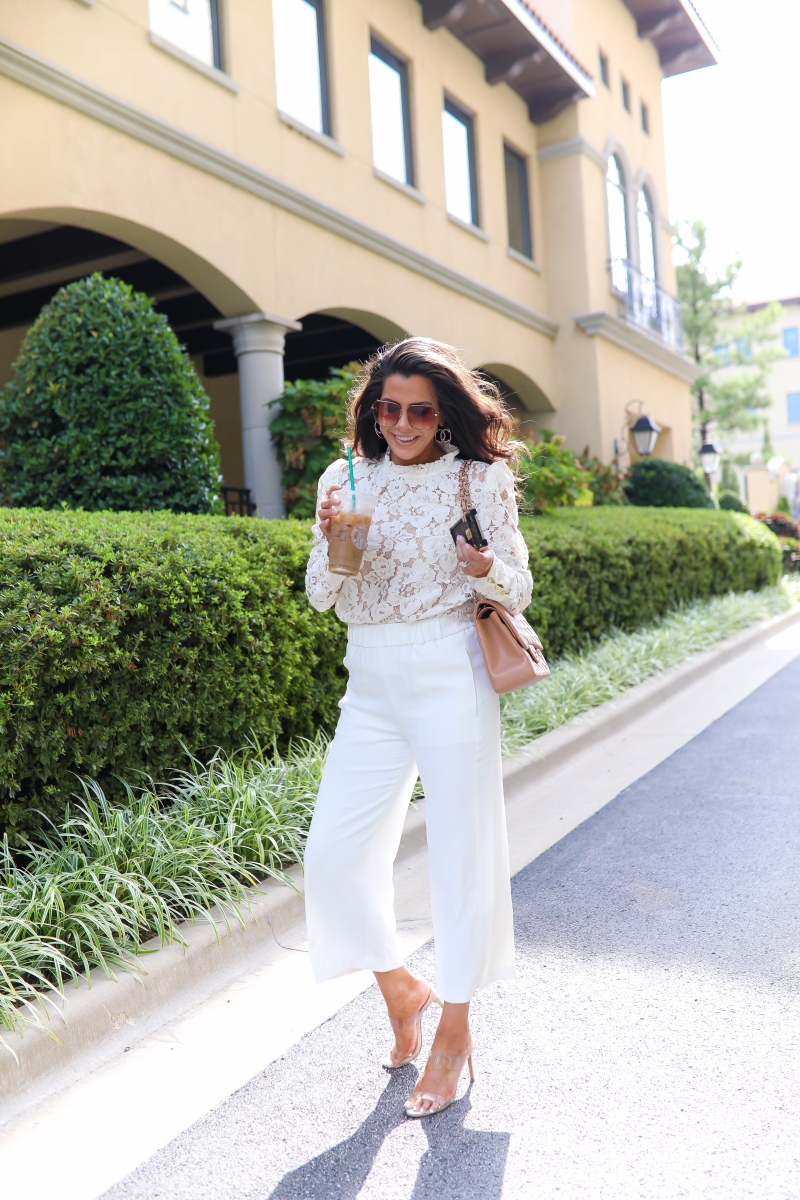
left=0, top=509, right=345, bottom=841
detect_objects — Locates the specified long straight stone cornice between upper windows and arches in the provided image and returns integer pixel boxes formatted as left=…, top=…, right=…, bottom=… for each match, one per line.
left=0, top=37, right=558, bottom=338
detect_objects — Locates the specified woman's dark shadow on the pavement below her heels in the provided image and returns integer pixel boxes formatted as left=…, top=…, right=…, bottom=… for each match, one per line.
left=269, top=1070, right=511, bottom=1200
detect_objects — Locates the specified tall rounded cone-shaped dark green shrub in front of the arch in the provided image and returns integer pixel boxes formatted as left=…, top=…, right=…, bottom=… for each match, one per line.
left=0, top=274, right=221, bottom=512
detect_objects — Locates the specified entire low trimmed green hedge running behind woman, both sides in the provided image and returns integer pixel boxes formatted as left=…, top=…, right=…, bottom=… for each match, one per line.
left=0, top=506, right=781, bottom=842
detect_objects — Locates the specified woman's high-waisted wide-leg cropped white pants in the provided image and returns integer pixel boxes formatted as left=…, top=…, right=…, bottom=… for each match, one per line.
left=305, top=617, right=515, bottom=1003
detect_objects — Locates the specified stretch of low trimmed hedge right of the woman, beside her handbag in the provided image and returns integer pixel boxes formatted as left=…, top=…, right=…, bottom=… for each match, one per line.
left=521, top=506, right=781, bottom=656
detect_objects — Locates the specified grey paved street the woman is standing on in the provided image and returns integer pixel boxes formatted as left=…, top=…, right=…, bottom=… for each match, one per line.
left=107, top=659, right=800, bottom=1200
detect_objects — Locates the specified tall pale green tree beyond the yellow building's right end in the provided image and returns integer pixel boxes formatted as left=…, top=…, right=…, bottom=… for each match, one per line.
left=676, top=221, right=783, bottom=446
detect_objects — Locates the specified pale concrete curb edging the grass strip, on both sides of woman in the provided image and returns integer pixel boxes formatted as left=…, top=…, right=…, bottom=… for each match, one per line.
left=0, top=610, right=800, bottom=1123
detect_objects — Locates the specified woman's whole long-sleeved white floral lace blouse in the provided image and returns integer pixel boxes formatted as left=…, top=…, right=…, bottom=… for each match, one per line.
left=306, top=448, right=533, bottom=625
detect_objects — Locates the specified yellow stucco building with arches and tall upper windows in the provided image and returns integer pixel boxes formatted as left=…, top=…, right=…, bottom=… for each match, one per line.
left=0, top=0, right=715, bottom=516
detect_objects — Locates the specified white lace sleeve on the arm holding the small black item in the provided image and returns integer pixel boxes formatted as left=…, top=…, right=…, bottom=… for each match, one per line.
left=470, top=453, right=534, bottom=616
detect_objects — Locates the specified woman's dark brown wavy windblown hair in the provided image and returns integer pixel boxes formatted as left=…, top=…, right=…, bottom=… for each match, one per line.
left=348, top=337, right=524, bottom=467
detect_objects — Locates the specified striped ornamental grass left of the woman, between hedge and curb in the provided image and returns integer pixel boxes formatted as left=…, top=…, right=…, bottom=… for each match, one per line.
left=0, top=734, right=327, bottom=1044
